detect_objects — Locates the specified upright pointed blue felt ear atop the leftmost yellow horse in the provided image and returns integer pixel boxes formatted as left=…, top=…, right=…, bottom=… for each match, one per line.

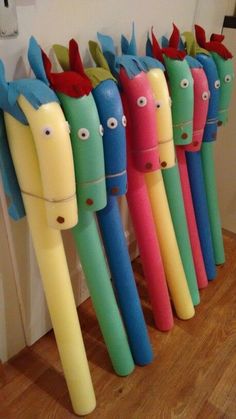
left=28, top=36, right=49, bottom=86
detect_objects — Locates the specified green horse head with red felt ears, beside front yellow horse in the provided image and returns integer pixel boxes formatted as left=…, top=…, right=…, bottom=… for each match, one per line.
left=43, top=40, right=106, bottom=211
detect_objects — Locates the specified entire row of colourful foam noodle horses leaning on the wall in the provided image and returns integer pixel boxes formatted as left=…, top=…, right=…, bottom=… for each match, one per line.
left=0, top=26, right=234, bottom=414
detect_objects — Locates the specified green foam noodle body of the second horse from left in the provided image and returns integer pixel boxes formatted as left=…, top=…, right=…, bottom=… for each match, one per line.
left=58, top=93, right=134, bottom=375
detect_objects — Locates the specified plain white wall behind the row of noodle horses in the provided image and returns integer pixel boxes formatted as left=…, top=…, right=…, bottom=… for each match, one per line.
left=0, top=0, right=235, bottom=360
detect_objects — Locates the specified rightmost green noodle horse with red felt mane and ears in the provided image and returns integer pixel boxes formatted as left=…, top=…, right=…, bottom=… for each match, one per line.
left=195, top=25, right=234, bottom=265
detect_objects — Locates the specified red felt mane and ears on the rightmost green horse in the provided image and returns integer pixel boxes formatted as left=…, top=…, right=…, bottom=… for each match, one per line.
left=195, top=25, right=233, bottom=60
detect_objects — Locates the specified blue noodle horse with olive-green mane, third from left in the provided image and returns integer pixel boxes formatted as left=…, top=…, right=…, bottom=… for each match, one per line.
left=50, top=40, right=153, bottom=365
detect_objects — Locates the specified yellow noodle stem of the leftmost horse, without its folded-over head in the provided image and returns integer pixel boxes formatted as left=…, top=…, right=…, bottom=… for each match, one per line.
left=5, top=112, right=96, bottom=415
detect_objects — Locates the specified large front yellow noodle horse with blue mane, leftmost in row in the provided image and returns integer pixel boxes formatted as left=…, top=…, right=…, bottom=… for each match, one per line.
left=0, top=62, right=96, bottom=415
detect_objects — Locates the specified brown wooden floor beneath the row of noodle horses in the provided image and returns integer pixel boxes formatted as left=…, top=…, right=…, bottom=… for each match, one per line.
left=0, top=233, right=236, bottom=419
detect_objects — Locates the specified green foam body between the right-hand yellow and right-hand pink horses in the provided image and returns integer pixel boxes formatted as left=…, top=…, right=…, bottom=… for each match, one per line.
left=163, top=55, right=199, bottom=304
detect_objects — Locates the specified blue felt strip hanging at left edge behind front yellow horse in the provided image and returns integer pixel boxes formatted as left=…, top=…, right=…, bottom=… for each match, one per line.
left=0, top=111, right=25, bottom=220
